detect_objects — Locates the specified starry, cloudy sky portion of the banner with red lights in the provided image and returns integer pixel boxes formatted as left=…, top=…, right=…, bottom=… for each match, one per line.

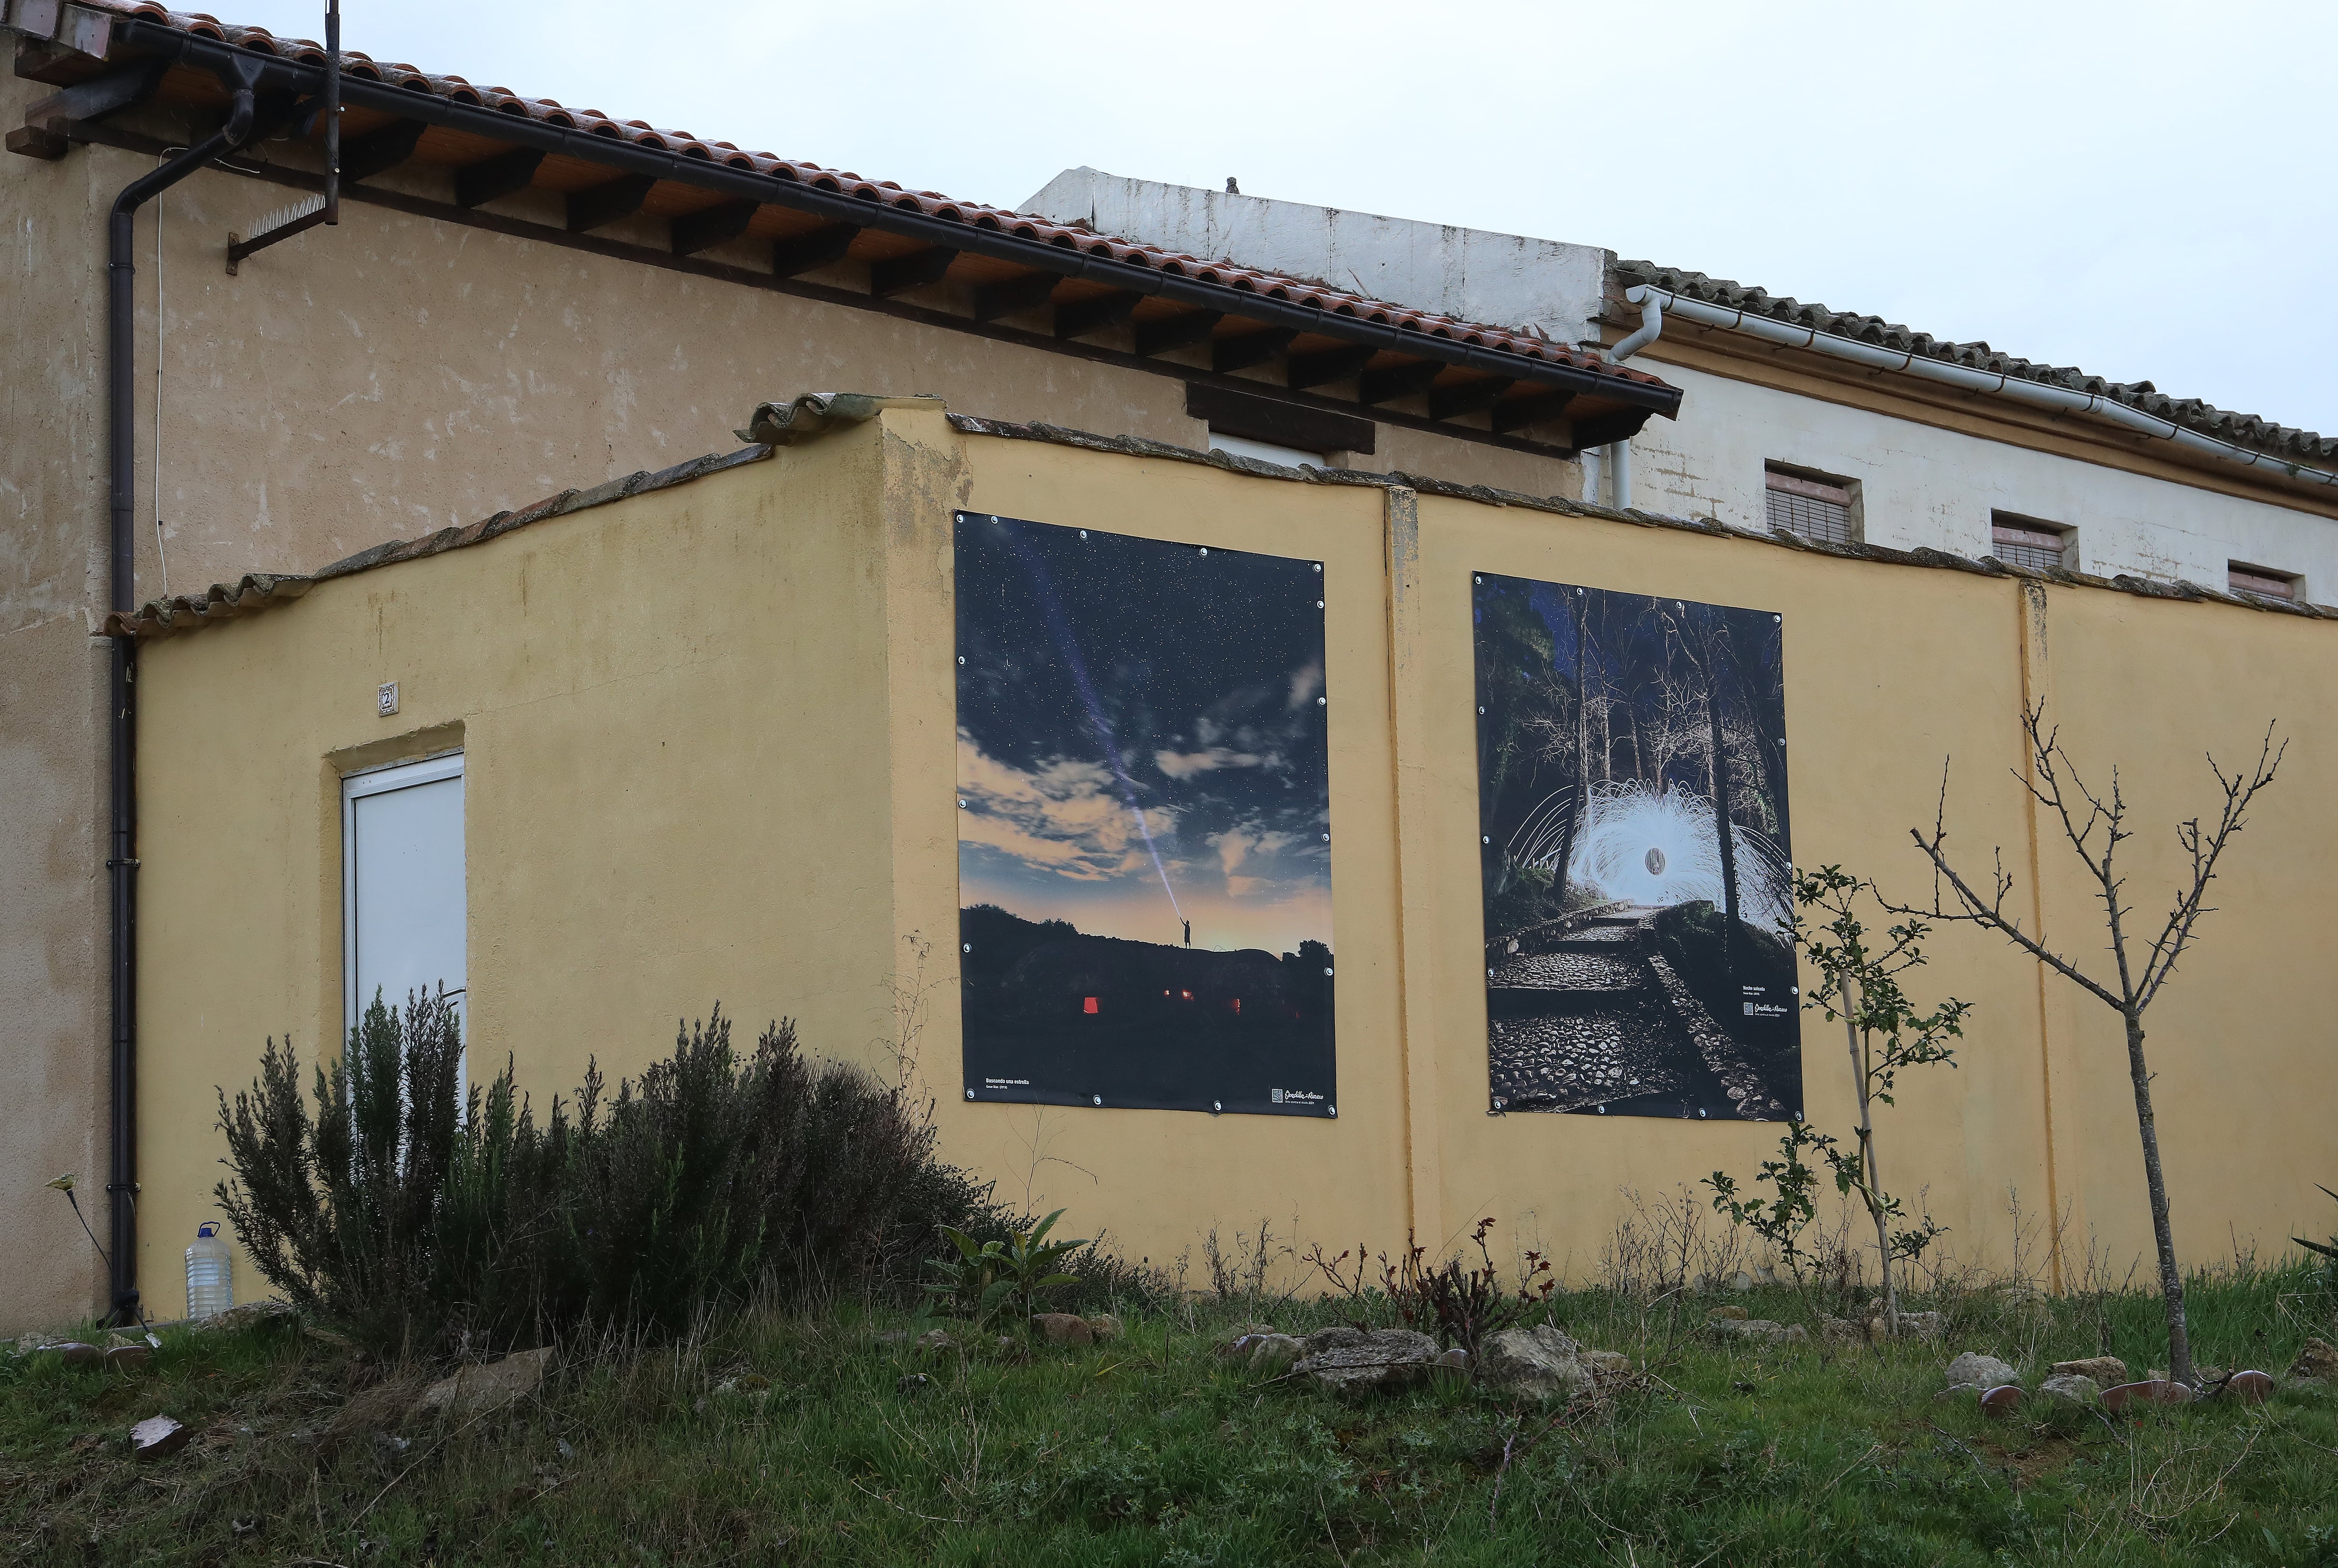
left=956, top=514, right=1330, bottom=953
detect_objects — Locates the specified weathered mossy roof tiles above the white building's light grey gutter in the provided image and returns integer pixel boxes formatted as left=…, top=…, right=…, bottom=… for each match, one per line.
left=1616, top=262, right=2338, bottom=460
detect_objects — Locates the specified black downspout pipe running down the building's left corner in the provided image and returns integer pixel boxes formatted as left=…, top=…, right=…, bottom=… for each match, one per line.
left=105, top=82, right=257, bottom=1323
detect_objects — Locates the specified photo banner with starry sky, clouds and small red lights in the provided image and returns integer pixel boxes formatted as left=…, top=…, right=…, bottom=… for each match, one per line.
left=956, top=512, right=1337, bottom=1117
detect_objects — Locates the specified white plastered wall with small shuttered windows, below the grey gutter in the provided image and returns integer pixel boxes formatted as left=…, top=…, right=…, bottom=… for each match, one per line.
left=1632, top=355, right=2338, bottom=603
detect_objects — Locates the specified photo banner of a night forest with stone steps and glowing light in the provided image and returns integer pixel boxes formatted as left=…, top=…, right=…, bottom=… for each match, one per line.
left=1473, top=573, right=1803, bottom=1119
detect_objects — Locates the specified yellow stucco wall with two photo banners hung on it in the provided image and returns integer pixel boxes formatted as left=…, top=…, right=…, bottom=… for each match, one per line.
left=140, top=407, right=2338, bottom=1313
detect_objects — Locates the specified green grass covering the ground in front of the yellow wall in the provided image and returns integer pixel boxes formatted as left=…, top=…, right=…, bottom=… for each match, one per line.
left=0, top=1271, right=2338, bottom=1568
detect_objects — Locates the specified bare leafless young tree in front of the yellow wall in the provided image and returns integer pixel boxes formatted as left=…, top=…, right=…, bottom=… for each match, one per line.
left=1884, top=704, right=2289, bottom=1383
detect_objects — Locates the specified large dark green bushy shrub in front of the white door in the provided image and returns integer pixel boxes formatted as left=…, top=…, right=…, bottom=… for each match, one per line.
left=217, top=995, right=1001, bottom=1351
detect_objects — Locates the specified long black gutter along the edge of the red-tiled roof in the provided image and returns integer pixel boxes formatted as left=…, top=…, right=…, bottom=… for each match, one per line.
left=115, top=19, right=1681, bottom=418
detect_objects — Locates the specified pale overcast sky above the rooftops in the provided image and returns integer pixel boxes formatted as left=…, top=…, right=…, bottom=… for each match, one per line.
left=215, top=0, right=2338, bottom=432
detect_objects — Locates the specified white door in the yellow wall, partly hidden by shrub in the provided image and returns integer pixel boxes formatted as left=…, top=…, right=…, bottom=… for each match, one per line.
left=341, top=753, right=465, bottom=1028
